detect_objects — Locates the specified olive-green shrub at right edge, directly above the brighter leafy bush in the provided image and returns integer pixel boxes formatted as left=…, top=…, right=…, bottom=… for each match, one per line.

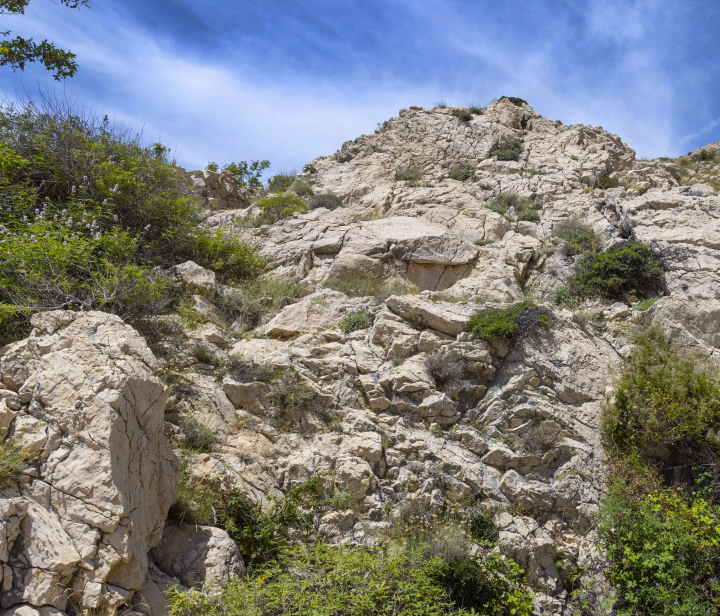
left=602, top=329, right=720, bottom=453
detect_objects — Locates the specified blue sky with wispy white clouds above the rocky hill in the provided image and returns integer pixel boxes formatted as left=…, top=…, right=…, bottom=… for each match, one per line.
left=0, top=0, right=720, bottom=176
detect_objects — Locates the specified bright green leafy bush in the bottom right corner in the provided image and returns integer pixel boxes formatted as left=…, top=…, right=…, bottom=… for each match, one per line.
left=599, top=473, right=720, bottom=616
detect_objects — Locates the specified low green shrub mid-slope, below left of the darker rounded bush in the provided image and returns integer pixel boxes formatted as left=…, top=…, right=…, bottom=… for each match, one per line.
left=469, top=299, right=554, bottom=341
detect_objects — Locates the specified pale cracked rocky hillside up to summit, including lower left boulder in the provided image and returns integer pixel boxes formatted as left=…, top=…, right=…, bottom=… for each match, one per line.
left=0, top=97, right=720, bottom=616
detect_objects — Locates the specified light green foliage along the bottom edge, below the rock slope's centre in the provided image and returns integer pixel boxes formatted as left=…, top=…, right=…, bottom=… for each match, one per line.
left=170, top=543, right=532, bottom=616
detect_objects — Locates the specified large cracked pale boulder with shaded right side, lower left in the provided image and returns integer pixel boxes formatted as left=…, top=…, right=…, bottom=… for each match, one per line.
left=0, top=311, right=178, bottom=614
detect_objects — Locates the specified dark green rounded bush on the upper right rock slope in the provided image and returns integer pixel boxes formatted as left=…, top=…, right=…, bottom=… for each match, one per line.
left=566, top=241, right=664, bottom=301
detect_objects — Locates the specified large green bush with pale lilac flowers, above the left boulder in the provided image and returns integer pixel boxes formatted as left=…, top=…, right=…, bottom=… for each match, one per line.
left=0, top=98, right=264, bottom=341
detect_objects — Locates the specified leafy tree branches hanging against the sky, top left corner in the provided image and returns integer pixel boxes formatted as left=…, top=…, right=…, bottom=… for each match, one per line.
left=0, top=0, right=89, bottom=81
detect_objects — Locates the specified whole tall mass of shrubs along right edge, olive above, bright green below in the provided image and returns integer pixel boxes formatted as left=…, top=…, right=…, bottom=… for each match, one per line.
left=599, top=328, right=720, bottom=616
